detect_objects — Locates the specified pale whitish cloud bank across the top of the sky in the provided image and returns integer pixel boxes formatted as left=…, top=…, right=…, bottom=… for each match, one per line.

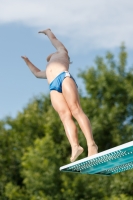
left=0, top=0, right=133, bottom=49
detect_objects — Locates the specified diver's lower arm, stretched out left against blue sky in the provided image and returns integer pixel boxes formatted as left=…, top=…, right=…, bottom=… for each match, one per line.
left=21, top=56, right=47, bottom=79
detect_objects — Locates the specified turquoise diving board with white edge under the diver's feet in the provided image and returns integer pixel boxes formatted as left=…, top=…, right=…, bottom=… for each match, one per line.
left=60, top=141, right=133, bottom=176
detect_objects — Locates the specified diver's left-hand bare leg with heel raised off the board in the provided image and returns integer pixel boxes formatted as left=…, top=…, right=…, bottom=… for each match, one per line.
left=50, top=91, right=83, bottom=162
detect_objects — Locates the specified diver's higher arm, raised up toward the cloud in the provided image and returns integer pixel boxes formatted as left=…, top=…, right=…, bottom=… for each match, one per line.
left=39, top=29, right=68, bottom=53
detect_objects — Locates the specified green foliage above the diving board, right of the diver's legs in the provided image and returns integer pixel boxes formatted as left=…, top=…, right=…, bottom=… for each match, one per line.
left=80, top=43, right=133, bottom=151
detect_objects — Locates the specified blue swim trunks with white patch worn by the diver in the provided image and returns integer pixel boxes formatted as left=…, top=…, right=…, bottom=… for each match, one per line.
left=49, top=71, right=78, bottom=93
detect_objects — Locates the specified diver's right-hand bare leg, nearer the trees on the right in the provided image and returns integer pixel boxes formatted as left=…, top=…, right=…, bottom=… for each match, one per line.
left=63, top=77, right=98, bottom=156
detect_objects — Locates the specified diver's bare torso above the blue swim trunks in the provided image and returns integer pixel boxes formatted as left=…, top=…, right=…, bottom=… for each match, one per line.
left=46, top=51, right=69, bottom=83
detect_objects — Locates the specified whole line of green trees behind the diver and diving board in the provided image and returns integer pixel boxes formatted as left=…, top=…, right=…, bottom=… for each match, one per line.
left=0, top=45, right=133, bottom=200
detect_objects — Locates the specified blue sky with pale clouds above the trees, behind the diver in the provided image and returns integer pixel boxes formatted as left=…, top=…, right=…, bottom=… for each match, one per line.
left=0, top=0, right=133, bottom=119
